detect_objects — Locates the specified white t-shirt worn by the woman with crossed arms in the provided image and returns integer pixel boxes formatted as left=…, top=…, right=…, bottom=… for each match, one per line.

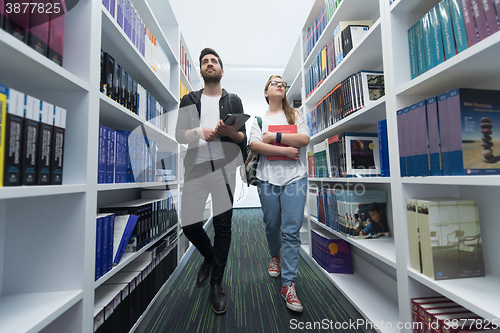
left=249, top=112, right=310, bottom=186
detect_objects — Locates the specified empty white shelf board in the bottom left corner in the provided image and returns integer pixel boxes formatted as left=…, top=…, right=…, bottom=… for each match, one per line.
left=0, top=290, right=83, bottom=332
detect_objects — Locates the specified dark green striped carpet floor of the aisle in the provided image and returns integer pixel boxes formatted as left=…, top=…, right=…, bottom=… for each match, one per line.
left=146, top=208, right=368, bottom=333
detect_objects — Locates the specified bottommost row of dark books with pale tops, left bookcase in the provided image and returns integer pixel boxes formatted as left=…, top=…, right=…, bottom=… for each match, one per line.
left=93, top=243, right=177, bottom=333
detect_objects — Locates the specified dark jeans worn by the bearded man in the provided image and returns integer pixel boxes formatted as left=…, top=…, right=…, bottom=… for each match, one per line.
left=181, top=160, right=234, bottom=285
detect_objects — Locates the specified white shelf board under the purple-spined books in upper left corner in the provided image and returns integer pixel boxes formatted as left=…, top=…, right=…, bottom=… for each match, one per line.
left=0, top=29, right=89, bottom=93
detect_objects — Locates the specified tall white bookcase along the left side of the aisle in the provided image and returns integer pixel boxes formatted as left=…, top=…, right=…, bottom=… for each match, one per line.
left=0, top=0, right=200, bottom=333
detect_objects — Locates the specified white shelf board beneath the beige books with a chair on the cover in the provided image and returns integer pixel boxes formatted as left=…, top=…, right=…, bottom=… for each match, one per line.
left=408, top=269, right=500, bottom=321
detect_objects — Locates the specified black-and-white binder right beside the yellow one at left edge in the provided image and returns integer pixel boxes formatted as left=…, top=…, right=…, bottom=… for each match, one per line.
left=0, top=86, right=24, bottom=186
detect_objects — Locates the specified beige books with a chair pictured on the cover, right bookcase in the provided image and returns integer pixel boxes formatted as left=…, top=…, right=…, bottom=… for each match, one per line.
left=406, top=198, right=485, bottom=280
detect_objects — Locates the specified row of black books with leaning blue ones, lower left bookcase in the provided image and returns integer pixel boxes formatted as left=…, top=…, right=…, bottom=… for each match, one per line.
left=96, top=189, right=178, bottom=260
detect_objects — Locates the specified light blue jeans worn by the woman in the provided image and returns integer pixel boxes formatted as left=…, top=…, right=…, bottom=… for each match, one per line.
left=257, top=178, right=307, bottom=287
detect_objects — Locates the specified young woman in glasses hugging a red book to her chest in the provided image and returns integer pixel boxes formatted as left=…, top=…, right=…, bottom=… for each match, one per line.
left=250, top=75, right=310, bottom=312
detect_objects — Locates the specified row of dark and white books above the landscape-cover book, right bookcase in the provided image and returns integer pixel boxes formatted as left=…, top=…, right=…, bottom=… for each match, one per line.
left=306, top=71, right=385, bottom=135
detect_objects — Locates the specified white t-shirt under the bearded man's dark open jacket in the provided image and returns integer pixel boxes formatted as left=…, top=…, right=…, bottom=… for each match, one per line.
left=194, top=94, right=224, bottom=164
